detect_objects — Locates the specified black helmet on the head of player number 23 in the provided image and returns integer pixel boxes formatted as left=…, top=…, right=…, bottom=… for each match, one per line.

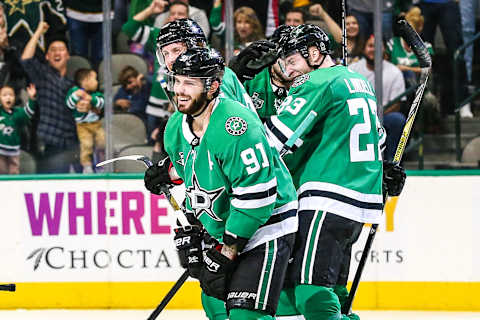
left=278, top=24, right=331, bottom=60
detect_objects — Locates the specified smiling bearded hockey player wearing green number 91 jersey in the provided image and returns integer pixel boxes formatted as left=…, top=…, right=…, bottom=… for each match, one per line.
left=145, top=48, right=297, bottom=320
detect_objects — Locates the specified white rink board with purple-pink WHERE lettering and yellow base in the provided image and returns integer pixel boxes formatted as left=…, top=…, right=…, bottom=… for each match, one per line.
left=0, top=171, right=480, bottom=311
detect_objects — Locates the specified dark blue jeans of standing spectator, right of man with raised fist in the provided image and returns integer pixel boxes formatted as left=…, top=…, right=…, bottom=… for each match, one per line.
left=68, top=18, right=103, bottom=67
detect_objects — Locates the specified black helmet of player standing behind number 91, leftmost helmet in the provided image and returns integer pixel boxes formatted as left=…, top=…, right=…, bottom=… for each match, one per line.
left=157, top=19, right=207, bottom=49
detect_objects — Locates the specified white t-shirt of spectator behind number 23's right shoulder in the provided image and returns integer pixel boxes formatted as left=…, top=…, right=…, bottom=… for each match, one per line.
left=348, top=58, right=406, bottom=105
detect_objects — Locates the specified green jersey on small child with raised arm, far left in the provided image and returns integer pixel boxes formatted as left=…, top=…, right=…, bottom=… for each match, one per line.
left=0, top=99, right=36, bottom=156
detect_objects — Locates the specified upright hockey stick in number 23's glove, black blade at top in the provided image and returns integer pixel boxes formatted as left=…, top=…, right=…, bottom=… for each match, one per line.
left=342, top=20, right=432, bottom=314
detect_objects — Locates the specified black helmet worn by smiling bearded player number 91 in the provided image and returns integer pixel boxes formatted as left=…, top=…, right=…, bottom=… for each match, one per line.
left=168, top=47, right=225, bottom=91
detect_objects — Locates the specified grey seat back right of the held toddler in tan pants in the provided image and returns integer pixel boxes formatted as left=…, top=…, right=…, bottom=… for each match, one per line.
left=103, top=113, right=147, bottom=154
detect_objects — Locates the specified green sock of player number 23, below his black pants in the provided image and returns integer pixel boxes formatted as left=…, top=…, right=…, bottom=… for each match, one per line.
left=295, top=284, right=342, bottom=320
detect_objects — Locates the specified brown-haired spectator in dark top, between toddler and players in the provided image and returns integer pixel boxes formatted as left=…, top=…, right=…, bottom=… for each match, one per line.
left=113, top=66, right=151, bottom=124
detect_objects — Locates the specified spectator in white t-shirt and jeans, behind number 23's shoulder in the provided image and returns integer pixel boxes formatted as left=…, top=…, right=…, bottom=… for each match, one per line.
left=349, top=35, right=406, bottom=160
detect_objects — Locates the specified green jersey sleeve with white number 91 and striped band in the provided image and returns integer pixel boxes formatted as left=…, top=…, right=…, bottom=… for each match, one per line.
left=218, top=116, right=277, bottom=239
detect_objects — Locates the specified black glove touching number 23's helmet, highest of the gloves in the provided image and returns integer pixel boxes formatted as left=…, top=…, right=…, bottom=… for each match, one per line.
left=229, top=40, right=278, bottom=82
